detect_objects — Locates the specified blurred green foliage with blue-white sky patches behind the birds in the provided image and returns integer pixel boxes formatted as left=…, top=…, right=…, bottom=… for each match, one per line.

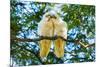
left=10, top=0, right=95, bottom=66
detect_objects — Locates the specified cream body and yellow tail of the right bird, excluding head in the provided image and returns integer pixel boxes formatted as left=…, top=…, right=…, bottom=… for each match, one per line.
left=54, top=21, right=67, bottom=58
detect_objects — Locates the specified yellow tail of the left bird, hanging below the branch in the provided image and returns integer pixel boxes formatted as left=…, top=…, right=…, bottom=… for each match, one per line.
left=40, top=40, right=51, bottom=58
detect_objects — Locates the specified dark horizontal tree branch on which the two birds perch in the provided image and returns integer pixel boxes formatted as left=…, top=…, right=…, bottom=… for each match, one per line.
left=11, top=36, right=94, bottom=48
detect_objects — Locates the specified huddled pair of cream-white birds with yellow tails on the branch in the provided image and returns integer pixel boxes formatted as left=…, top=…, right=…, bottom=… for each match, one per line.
left=38, top=11, right=68, bottom=58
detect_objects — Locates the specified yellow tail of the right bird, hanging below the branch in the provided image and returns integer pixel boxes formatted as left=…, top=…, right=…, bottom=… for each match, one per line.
left=54, top=38, right=65, bottom=58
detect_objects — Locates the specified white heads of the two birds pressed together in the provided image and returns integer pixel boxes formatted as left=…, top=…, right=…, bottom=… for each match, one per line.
left=43, top=10, right=59, bottom=21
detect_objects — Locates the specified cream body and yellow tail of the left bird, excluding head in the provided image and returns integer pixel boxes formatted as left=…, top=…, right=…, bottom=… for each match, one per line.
left=38, top=21, right=52, bottom=58
